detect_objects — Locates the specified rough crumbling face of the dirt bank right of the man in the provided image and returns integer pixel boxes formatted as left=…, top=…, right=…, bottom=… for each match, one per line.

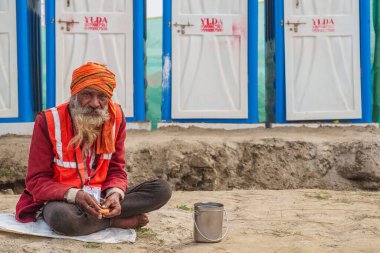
left=127, top=131, right=380, bottom=190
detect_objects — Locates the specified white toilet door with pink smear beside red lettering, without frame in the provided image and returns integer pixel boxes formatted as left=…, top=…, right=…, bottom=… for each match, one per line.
left=171, top=0, right=248, bottom=119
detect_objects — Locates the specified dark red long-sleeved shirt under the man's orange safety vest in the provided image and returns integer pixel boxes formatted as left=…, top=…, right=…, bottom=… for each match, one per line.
left=16, top=113, right=127, bottom=222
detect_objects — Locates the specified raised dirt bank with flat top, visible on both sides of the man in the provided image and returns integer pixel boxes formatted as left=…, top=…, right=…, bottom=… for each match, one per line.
left=0, top=127, right=380, bottom=192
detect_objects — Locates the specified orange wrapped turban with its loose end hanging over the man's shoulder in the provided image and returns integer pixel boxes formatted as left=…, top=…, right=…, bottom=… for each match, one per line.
left=70, top=62, right=116, bottom=154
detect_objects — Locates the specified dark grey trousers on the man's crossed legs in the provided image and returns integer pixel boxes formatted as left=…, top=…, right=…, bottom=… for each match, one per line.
left=42, top=179, right=171, bottom=236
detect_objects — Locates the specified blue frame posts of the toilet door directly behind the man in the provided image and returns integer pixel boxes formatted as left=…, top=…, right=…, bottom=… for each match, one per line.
left=46, top=0, right=146, bottom=122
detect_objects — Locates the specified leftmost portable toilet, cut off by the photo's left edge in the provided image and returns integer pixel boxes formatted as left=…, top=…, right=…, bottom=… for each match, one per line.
left=0, top=0, right=41, bottom=126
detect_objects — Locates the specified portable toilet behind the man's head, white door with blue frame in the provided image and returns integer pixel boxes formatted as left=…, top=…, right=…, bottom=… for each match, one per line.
left=46, top=0, right=145, bottom=122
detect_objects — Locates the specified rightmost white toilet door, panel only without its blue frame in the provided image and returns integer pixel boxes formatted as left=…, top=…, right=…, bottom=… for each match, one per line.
left=284, top=0, right=362, bottom=120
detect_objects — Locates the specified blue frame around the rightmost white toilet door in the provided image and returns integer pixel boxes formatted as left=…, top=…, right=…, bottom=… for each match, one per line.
left=265, top=0, right=372, bottom=123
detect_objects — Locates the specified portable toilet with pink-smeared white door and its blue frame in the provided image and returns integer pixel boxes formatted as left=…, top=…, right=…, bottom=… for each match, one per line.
left=161, top=0, right=258, bottom=124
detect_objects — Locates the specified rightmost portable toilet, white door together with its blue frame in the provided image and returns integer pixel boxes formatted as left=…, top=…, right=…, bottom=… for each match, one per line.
left=265, top=0, right=372, bottom=123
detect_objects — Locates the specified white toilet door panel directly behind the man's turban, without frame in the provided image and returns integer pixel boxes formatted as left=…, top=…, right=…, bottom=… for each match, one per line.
left=55, top=0, right=134, bottom=117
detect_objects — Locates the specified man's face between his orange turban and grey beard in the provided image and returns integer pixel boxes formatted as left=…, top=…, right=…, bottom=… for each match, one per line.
left=77, top=87, right=108, bottom=110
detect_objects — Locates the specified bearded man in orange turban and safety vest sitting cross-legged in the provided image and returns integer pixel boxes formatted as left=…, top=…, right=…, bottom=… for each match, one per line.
left=16, top=63, right=171, bottom=235
